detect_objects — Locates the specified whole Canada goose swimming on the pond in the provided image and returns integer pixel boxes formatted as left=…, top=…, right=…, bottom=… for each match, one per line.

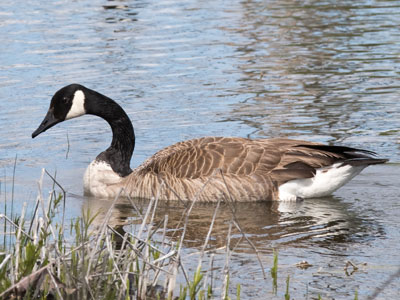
left=32, top=84, right=387, bottom=201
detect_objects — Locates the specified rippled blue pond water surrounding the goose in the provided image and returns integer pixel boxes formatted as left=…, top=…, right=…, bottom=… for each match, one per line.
left=0, top=0, right=400, bottom=299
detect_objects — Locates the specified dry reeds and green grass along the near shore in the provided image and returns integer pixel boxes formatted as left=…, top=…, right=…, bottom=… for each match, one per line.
left=0, top=170, right=394, bottom=300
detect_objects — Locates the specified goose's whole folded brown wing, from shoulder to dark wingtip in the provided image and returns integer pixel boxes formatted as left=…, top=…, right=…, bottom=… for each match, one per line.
left=138, top=137, right=376, bottom=184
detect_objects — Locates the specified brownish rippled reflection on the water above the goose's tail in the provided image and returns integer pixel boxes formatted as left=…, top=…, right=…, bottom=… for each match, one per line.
left=222, top=1, right=399, bottom=149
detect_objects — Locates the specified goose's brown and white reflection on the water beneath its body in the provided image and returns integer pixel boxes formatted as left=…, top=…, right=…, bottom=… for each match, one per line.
left=82, top=197, right=384, bottom=253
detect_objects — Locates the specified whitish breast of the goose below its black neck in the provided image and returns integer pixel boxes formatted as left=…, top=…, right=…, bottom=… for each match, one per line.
left=83, top=160, right=122, bottom=198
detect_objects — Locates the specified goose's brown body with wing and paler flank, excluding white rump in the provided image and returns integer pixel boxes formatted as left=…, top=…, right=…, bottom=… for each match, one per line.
left=117, top=137, right=380, bottom=201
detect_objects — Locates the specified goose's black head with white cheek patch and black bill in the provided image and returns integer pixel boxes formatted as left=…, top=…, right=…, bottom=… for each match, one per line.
left=32, top=84, right=87, bottom=138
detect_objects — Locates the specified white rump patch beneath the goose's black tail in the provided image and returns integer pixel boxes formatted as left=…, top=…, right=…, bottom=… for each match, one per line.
left=279, top=163, right=366, bottom=201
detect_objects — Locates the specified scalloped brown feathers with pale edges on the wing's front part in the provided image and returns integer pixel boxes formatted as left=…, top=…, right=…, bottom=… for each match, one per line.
left=139, top=137, right=280, bottom=179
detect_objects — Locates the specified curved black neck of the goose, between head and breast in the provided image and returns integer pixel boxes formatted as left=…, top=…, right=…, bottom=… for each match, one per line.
left=85, top=89, right=135, bottom=177
